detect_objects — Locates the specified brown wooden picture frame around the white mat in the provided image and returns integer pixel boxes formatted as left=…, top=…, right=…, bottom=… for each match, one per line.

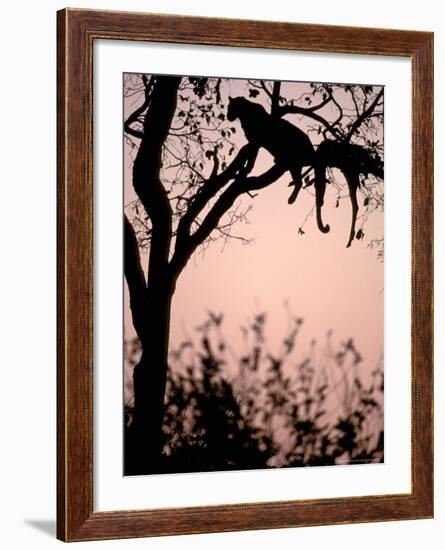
left=57, top=9, right=433, bottom=541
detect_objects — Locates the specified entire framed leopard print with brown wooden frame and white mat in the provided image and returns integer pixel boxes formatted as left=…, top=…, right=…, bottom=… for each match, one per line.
left=57, top=9, right=433, bottom=541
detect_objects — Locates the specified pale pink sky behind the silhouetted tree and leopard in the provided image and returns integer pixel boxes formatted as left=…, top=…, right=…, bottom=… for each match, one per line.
left=124, top=75, right=384, bottom=402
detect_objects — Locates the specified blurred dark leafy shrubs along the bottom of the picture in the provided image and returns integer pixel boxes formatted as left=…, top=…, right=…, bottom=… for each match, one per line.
left=125, top=313, right=383, bottom=473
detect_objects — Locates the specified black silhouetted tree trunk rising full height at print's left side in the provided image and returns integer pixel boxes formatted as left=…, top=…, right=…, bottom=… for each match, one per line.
left=124, top=76, right=181, bottom=475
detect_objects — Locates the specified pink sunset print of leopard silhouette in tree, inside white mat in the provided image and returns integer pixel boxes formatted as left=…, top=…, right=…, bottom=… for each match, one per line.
left=122, top=71, right=384, bottom=476
